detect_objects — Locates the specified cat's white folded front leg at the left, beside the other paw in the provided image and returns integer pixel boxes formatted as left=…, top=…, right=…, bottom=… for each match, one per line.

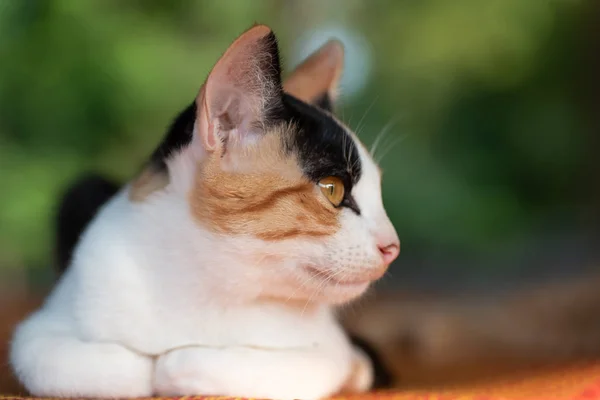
left=10, top=311, right=153, bottom=398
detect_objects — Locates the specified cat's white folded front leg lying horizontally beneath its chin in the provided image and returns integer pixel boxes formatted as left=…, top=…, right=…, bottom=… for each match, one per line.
left=154, top=347, right=351, bottom=400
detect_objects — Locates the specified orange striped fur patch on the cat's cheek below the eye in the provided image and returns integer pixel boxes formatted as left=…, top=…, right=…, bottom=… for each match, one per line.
left=189, top=128, right=339, bottom=241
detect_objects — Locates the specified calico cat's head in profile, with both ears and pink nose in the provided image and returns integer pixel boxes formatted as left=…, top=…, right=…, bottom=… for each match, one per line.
left=131, top=25, right=400, bottom=303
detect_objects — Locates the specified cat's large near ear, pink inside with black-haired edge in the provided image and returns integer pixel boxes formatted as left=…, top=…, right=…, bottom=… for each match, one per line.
left=196, top=25, right=283, bottom=152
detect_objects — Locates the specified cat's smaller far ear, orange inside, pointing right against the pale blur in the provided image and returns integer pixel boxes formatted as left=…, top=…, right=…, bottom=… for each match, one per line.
left=283, top=40, right=344, bottom=111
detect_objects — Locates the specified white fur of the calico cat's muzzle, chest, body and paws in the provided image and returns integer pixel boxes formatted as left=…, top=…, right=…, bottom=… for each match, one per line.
left=10, top=123, right=397, bottom=399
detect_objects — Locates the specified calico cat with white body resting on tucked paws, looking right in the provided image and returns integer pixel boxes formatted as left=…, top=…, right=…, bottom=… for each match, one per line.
left=9, top=25, right=400, bottom=399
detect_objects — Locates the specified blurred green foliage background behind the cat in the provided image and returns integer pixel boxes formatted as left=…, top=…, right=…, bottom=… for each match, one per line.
left=0, top=0, right=600, bottom=290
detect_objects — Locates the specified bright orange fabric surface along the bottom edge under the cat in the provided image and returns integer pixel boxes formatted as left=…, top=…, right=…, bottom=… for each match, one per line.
left=0, top=364, right=600, bottom=400
